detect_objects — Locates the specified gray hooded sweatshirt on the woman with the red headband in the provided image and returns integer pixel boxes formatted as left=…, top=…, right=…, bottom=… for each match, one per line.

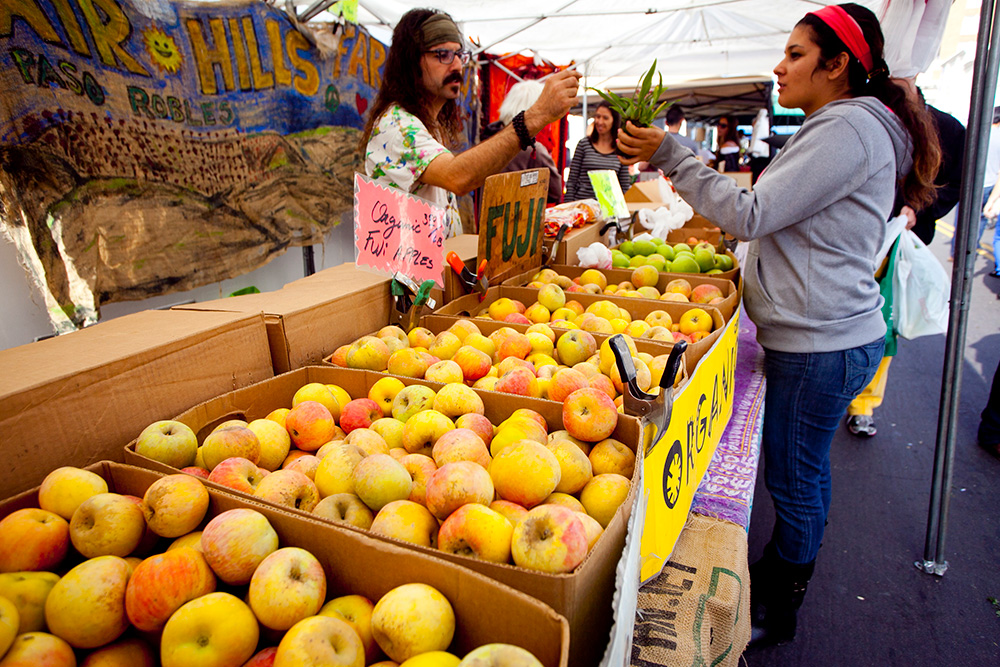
left=650, top=97, right=913, bottom=353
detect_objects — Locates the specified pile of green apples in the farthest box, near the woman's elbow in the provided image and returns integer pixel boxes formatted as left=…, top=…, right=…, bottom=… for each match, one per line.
left=611, top=237, right=734, bottom=275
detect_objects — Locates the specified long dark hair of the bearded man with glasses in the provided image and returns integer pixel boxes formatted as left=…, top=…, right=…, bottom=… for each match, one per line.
left=358, top=9, right=462, bottom=157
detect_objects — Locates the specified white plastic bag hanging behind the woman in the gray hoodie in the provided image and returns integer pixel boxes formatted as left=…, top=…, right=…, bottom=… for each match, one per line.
left=892, top=229, right=951, bottom=339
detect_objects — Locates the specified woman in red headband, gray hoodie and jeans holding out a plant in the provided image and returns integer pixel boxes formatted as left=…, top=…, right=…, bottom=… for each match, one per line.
left=619, top=3, right=940, bottom=646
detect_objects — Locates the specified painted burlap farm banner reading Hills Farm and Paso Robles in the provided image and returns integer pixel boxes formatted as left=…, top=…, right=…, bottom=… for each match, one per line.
left=0, top=0, right=470, bottom=332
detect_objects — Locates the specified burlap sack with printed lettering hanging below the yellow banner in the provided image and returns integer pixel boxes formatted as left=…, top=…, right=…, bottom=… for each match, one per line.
left=631, top=514, right=750, bottom=667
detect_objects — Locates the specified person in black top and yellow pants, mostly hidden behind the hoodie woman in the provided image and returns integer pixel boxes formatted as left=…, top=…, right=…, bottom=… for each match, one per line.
left=846, top=77, right=965, bottom=438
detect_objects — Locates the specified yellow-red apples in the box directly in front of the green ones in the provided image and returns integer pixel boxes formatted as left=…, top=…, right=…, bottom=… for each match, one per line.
left=527, top=265, right=725, bottom=308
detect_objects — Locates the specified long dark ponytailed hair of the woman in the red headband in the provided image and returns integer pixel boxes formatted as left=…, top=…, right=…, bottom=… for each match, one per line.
left=799, top=2, right=941, bottom=210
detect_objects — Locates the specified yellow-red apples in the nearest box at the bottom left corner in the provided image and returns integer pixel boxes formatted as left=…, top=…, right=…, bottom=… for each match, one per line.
left=0, top=467, right=541, bottom=667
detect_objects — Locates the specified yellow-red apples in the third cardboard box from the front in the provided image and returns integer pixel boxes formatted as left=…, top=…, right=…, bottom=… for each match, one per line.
left=331, top=318, right=684, bottom=407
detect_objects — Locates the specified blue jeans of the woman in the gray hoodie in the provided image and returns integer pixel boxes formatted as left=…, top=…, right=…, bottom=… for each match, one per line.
left=763, top=338, right=885, bottom=563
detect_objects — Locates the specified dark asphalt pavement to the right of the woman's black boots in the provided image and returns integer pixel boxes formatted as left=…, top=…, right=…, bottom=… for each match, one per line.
left=744, top=217, right=1000, bottom=667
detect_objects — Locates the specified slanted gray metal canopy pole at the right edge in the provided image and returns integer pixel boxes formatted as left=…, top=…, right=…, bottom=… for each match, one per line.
left=914, top=0, right=1000, bottom=577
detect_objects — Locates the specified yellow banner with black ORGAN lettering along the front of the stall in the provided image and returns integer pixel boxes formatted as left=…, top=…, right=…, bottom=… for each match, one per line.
left=639, top=309, right=742, bottom=583
